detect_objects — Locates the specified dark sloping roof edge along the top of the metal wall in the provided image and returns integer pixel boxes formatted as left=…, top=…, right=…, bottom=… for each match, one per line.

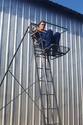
left=30, top=0, right=83, bottom=21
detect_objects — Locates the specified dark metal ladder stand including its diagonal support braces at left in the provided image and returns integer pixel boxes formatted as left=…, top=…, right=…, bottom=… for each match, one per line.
left=0, top=23, right=69, bottom=125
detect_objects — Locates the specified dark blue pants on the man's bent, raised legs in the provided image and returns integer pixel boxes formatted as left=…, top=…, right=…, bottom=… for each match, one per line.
left=40, top=30, right=61, bottom=48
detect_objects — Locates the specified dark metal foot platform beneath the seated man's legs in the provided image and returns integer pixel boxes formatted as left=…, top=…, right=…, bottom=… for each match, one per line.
left=34, top=44, right=70, bottom=59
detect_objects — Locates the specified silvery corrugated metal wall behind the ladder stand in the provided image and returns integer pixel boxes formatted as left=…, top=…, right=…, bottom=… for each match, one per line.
left=0, top=0, right=83, bottom=125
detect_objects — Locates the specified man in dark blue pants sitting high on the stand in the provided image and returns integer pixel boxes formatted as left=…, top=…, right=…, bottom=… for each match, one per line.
left=32, top=20, right=60, bottom=49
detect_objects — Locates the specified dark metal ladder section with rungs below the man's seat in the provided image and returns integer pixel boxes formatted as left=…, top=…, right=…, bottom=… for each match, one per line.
left=33, top=41, right=62, bottom=125
